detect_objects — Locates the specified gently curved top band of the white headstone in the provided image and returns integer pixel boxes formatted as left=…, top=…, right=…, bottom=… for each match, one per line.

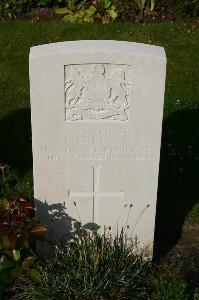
left=30, top=40, right=166, bottom=60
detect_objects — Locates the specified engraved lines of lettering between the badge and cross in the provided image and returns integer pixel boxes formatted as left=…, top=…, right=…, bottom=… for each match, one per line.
left=35, top=127, right=159, bottom=161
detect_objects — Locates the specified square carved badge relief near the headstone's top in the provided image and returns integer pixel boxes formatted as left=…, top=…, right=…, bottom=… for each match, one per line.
left=65, top=64, right=130, bottom=122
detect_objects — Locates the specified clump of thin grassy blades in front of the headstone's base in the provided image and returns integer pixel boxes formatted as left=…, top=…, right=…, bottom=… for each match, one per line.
left=11, top=233, right=150, bottom=299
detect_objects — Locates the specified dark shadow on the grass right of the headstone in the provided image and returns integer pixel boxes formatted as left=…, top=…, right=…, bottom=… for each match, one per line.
left=154, top=109, right=199, bottom=259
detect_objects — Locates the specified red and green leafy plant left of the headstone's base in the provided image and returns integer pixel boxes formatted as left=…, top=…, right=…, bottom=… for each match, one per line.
left=0, top=195, right=46, bottom=289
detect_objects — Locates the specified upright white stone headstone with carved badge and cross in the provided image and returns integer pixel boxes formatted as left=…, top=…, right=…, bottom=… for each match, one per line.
left=30, top=41, right=166, bottom=253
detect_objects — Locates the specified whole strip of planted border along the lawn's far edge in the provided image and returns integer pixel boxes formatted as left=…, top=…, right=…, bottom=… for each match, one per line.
left=0, top=0, right=199, bottom=18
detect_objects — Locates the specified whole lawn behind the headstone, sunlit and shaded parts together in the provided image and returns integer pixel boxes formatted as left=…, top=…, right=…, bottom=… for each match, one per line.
left=0, top=21, right=199, bottom=258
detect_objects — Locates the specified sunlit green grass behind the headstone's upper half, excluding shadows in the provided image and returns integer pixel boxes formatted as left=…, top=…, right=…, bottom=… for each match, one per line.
left=0, top=21, right=199, bottom=118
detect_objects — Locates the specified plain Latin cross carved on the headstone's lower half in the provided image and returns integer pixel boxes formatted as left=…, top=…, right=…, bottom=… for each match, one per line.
left=68, top=166, right=124, bottom=223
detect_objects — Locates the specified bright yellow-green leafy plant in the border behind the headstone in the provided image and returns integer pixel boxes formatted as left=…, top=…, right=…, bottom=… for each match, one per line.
left=55, top=0, right=118, bottom=24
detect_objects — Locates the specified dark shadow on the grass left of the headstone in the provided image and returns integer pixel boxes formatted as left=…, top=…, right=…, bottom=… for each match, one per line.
left=0, top=109, right=32, bottom=174
